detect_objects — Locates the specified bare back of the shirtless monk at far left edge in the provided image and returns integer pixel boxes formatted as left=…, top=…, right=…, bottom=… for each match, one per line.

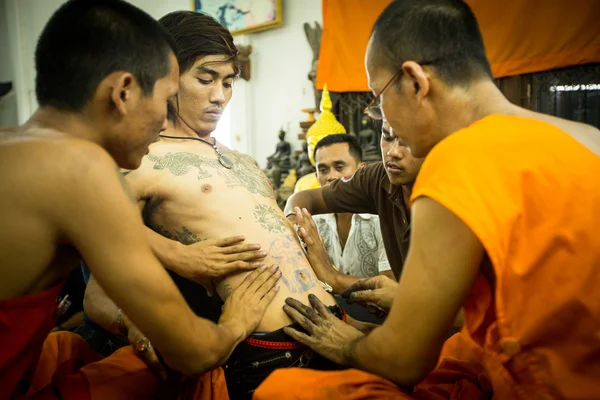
left=0, top=128, right=79, bottom=299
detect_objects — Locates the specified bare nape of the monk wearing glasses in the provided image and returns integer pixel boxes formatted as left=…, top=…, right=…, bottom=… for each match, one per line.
left=437, top=79, right=520, bottom=140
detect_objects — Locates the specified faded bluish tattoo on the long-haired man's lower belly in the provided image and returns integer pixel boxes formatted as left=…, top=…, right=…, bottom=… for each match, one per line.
left=269, top=234, right=317, bottom=293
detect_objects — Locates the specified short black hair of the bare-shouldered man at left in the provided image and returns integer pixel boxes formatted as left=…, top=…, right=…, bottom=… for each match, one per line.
left=35, top=0, right=176, bottom=111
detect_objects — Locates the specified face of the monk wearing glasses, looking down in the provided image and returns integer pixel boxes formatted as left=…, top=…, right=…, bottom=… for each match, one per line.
left=365, top=40, right=435, bottom=157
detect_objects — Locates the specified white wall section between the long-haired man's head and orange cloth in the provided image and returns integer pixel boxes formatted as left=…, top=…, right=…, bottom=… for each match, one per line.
left=231, top=0, right=323, bottom=167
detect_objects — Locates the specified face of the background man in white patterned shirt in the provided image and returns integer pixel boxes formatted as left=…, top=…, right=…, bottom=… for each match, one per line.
left=315, top=143, right=364, bottom=186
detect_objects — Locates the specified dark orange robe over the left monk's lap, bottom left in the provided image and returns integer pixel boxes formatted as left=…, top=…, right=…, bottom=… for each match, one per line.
left=19, top=332, right=229, bottom=400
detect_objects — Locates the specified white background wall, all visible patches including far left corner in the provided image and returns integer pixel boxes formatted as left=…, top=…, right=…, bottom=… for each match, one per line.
left=0, top=0, right=322, bottom=166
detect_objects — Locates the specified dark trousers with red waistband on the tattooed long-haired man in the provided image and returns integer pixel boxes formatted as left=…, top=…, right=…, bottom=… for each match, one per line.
left=224, top=306, right=345, bottom=400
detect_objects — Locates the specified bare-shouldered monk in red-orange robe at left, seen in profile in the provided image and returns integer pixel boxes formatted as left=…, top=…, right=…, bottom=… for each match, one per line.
left=0, top=0, right=280, bottom=400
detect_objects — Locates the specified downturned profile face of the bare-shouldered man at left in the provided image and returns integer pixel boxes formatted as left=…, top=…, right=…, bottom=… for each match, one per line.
left=107, top=54, right=179, bottom=169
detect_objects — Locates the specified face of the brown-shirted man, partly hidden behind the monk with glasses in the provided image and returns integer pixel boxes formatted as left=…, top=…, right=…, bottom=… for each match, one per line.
left=381, top=121, right=424, bottom=186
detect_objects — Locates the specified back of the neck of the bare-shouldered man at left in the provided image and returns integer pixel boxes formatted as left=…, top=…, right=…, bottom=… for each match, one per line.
left=23, top=106, right=104, bottom=146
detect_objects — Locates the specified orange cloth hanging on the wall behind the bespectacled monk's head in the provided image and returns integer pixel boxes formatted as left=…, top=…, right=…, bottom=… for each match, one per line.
left=317, top=0, right=600, bottom=92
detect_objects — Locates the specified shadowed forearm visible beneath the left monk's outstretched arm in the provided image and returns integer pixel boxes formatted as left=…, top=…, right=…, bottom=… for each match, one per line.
left=83, top=276, right=122, bottom=334
